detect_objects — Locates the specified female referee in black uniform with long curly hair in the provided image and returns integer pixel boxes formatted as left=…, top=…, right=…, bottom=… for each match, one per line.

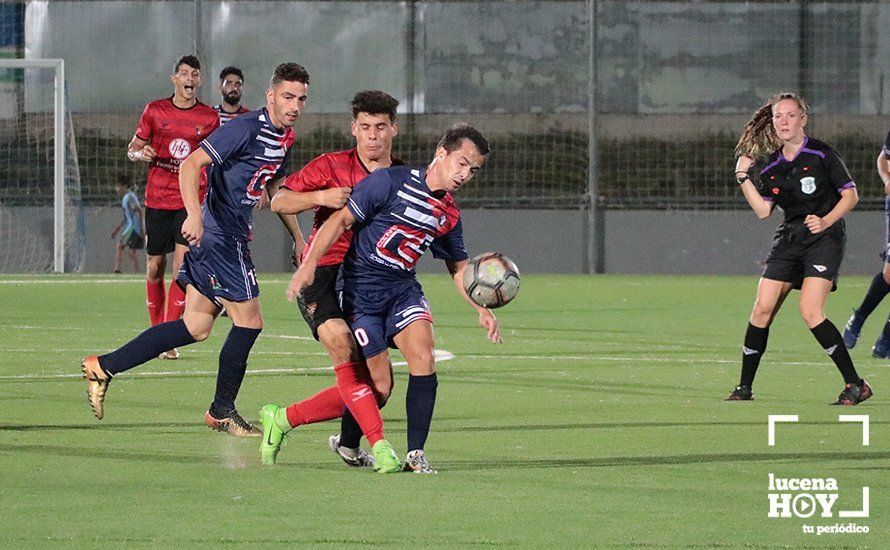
left=727, top=93, right=872, bottom=405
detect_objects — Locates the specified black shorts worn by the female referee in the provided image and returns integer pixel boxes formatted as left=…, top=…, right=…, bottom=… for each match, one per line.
left=763, top=227, right=847, bottom=291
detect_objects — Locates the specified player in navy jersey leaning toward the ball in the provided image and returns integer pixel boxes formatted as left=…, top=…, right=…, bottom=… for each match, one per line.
left=287, top=124, right=501, bottom=473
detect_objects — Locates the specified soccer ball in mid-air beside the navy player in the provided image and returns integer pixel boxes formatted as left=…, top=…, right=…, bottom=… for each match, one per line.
left=464, top=252, right=519, bottom=309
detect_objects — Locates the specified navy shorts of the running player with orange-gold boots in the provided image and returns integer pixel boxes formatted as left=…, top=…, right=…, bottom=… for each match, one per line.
left=176, top=231, right=260, bottom=307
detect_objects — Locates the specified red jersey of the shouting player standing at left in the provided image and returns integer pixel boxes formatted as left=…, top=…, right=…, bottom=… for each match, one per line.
left=136, top=96, right=219, bottom=210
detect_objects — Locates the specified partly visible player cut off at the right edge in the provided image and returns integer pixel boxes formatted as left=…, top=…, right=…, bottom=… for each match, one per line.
left=844, top=133, right=890, bottom=359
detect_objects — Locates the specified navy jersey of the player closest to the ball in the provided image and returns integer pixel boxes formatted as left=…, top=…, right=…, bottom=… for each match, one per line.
left=343, top=166, right=467, bottom=287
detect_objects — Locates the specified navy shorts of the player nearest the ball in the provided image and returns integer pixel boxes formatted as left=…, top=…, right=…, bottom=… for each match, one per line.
left=343, top=282, right=433, bottom=357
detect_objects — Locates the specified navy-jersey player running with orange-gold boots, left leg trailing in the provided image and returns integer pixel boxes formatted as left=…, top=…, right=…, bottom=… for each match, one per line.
left=82, top=63, right=320, bottom=436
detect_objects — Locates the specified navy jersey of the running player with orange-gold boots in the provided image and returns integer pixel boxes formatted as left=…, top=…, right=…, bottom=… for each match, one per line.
left=201, top=108, right=294, bottom=239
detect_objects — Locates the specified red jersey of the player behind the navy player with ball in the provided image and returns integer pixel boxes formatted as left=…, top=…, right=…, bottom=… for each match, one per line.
left=284, top=147, right=402, bottom=266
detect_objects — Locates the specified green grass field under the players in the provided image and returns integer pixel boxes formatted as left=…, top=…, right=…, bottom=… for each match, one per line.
left=0, top=275, right=890, bottom=548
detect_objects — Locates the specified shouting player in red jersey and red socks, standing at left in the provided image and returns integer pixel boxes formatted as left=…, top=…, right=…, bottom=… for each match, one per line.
left=127, top=55, right=219, bottom=359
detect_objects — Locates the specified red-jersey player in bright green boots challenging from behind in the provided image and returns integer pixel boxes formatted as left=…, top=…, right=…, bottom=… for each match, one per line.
left=262, top=90, right=402, bottom=466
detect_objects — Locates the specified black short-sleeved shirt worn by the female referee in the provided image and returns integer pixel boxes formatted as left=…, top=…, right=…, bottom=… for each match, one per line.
left=760, top=137, right=856, bottom=225
